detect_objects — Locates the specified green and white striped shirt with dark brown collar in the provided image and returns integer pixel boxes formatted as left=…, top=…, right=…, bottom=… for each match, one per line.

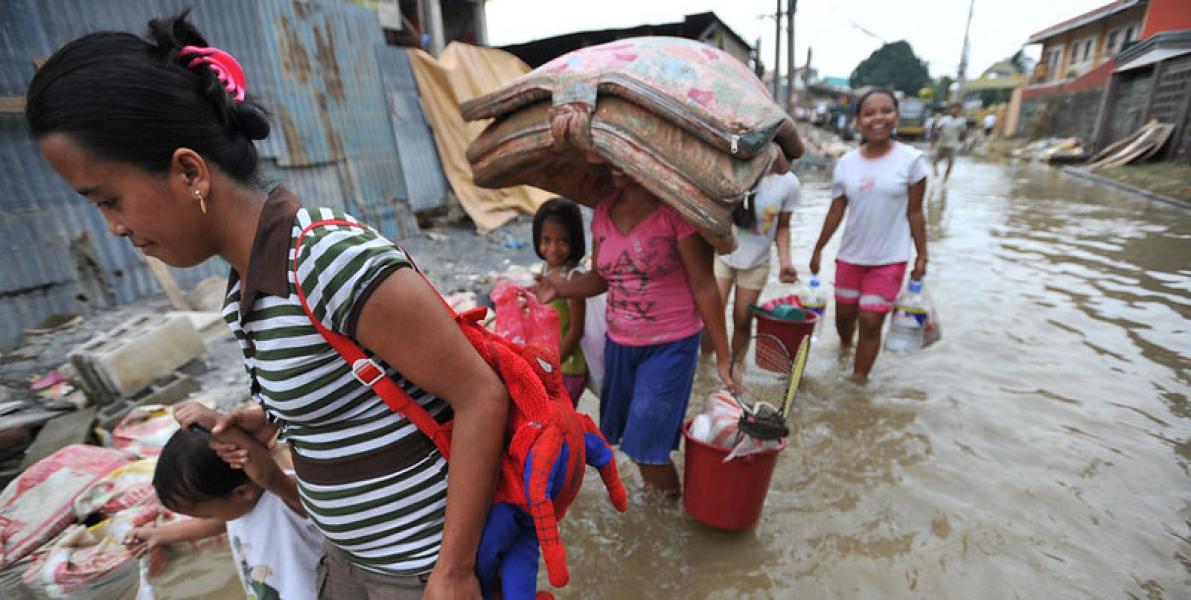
left=223, top=188, right=450, bottom=574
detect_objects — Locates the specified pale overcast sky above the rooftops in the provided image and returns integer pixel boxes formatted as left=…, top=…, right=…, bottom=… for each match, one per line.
left=487, top=0, right=1108, bottom=77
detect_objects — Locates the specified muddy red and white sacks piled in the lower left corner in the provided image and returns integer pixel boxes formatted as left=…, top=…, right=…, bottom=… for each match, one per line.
left=0, top=405, right=224, bottom=600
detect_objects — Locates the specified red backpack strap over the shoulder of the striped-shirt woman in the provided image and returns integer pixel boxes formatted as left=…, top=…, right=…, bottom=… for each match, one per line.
left=291, top=219, right=459, bottom=461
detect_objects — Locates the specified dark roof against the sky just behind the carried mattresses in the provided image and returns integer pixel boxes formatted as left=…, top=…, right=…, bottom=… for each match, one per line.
left=500, top=12, right=753, bottom=68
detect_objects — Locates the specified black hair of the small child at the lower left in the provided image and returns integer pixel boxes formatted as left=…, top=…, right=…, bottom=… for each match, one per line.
left=152, top=429, right=249, bottom=511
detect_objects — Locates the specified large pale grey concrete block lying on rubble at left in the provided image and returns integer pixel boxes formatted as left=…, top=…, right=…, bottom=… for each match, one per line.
left=68, top=313, right=206, bottom=404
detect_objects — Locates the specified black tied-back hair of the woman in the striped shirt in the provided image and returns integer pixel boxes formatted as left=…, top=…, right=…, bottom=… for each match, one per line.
left=25, top=11, right=269, bottom=185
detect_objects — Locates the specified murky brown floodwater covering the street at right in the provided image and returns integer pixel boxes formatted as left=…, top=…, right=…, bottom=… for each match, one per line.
left=158, top=161, right=1191, bottom=599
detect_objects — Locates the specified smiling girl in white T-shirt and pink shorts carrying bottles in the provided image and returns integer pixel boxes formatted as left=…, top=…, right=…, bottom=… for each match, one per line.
left=810, top=89, right=927, bottom=382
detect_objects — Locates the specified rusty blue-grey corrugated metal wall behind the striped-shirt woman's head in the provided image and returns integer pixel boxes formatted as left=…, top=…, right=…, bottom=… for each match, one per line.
left=0, top=0, right=445, bottom=348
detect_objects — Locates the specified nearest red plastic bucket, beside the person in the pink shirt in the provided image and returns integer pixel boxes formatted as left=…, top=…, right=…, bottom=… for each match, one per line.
left=682, top=421, right=786, bottom=530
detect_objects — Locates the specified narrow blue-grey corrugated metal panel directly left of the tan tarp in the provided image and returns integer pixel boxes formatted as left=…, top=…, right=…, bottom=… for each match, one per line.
left=376, top=46, right=450, bottom=211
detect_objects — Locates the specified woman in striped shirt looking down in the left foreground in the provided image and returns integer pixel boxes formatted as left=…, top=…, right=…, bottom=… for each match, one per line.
left=26, top=13, right=507, bottom=599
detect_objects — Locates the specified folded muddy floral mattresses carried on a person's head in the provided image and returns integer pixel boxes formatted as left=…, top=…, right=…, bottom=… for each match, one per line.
left=461, top=37, right=803, bottom=252
